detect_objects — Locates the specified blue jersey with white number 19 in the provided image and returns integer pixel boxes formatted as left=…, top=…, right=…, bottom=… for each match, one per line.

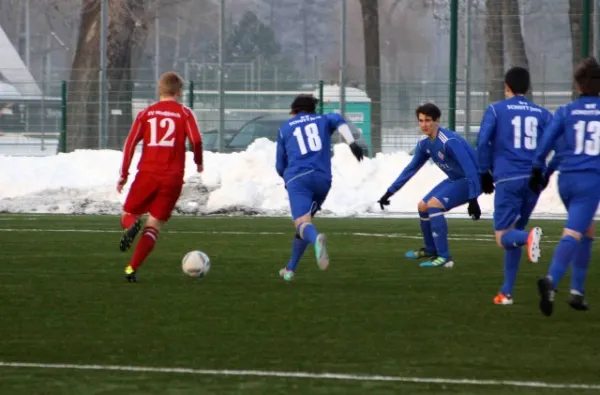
left=477, top=96, right=552, bottom=183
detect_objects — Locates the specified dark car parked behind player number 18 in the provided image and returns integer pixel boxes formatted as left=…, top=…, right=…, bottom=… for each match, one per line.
left=227, top=114, right=369, bottom=156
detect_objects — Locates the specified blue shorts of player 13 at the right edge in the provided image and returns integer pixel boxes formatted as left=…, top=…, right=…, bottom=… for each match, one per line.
left=558, top=172, right=600, bottom=233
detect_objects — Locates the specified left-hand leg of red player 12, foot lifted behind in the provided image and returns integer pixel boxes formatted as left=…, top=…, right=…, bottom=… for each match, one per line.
left=119, top=173, right=157, bottom=252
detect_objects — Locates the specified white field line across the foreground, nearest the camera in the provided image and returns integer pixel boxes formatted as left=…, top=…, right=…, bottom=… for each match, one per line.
left=0, top=361, right=600, bottom=390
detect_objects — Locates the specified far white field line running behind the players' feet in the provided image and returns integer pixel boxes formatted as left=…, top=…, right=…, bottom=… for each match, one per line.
left=0, top=228, right=559, bottom=243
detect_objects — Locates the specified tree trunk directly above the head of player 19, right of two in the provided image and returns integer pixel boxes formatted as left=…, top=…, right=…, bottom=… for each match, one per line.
left=503, top=0, right=533, bottom=99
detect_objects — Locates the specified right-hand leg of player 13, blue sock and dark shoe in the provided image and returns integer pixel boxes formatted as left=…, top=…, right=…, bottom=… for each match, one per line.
left=569, top=221, right=596, bottom=311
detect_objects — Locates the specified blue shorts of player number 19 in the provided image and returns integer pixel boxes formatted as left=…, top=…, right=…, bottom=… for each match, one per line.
left=494, top=177, right=539, bottom=231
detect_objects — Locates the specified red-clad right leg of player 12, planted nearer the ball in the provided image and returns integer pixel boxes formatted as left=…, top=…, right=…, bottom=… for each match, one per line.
left=125, top=180, right=183, bottom=282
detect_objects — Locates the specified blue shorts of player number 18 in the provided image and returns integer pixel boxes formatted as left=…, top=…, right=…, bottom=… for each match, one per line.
left=286, top=172, right=331, bottom=221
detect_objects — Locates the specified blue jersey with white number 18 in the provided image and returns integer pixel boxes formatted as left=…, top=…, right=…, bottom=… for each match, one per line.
left=276, top=113, right=346, bottom=183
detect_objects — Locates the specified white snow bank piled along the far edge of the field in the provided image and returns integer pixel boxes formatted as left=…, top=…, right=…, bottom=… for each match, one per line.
left=0, top=139, right=565, bottom=217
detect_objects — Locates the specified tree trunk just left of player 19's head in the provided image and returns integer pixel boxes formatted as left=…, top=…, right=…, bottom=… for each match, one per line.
left=485, top=0, right=504, bottom=103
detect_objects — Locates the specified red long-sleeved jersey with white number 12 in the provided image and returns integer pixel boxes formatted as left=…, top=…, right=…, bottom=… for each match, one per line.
left=121, top=100, right=202, bottom=178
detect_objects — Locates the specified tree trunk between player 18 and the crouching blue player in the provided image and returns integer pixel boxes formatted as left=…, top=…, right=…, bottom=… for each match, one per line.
left=360, top=0, right=381, bottom=154
